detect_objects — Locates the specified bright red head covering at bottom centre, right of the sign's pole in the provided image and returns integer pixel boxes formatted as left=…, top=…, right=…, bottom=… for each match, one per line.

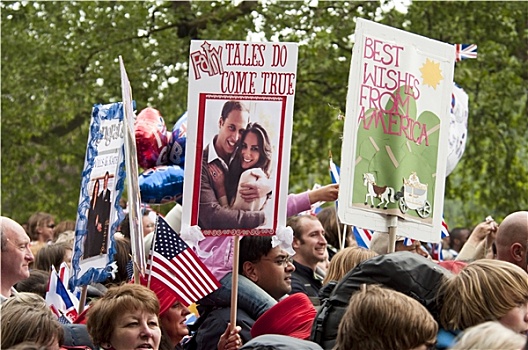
left=251, top=293, right=317, bottom=339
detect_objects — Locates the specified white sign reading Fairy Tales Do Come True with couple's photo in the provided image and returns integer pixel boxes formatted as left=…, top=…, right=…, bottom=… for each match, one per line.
left=182, top=41, right=297, bottom=236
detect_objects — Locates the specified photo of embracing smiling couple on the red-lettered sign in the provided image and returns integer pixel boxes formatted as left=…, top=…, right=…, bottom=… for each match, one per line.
left=198, top=100, right=278, bottom=230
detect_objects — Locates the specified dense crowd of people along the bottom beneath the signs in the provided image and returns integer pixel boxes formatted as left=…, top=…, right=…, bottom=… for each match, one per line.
left=1, top=204, right=528, bottom=350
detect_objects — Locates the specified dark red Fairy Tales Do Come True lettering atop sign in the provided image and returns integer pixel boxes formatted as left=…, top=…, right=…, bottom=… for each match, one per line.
left=191, top=41, right=295, bottom=95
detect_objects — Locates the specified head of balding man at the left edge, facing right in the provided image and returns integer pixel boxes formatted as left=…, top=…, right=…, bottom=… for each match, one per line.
left=0, top=216, right=34, bottom=301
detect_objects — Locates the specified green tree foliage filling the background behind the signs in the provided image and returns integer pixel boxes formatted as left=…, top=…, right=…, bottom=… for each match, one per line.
left=1, top=1, right=528, bottom=230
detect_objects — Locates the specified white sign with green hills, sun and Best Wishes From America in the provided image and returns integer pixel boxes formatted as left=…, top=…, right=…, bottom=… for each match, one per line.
left=339, top=19, right=455, bottom=242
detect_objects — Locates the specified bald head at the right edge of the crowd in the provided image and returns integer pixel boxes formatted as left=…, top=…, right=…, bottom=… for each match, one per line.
left=495, top=211, right=528, bottom=271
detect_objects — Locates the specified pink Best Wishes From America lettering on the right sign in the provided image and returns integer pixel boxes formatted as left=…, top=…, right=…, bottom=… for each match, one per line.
left=358, top=37, right=429, bottom=146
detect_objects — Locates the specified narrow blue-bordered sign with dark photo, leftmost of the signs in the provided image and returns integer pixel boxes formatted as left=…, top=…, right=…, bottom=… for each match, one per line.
left=70, top=103, right=125, bottom=286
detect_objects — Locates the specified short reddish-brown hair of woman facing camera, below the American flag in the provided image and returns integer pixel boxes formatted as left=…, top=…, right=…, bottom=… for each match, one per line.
left=86, top=283, right=159, bottom=345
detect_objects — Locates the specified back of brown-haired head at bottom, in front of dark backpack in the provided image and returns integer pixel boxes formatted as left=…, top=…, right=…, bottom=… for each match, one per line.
left=334, top=285, right=438, bottom=350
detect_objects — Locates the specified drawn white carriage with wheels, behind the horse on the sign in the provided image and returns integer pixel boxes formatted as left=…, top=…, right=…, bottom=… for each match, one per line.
left=394, top=172, right=431, bottom=218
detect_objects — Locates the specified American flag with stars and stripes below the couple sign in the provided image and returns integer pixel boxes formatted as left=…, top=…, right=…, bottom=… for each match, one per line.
left=146, top=215, right=220, bottom=306
